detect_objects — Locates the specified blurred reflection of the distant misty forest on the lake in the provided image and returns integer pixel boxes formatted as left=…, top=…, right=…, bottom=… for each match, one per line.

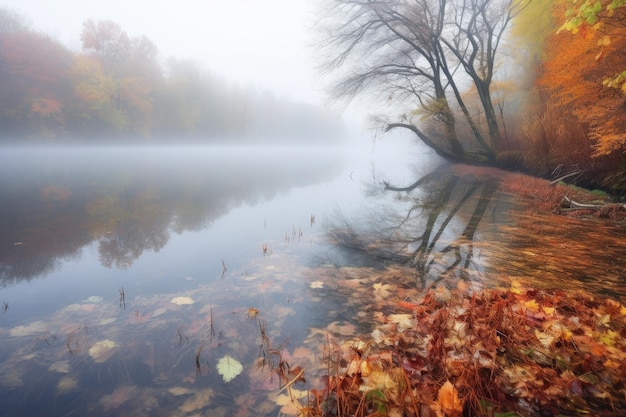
left=0, top=147, right=343, bottom=285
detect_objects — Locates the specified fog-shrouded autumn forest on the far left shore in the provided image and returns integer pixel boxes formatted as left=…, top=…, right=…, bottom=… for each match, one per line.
left=0, top=7, right=342, bottom=143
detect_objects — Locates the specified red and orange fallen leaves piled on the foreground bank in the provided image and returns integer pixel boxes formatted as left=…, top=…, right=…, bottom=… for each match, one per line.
left=292, top=269, right=626, bottom=417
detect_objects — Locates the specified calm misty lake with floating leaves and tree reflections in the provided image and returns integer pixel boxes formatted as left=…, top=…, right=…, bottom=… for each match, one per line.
left=0, top=139, right=626, bottom=416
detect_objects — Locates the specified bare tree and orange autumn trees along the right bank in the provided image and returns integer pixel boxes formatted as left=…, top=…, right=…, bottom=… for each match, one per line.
left=321, top=0, right=626, bottom=193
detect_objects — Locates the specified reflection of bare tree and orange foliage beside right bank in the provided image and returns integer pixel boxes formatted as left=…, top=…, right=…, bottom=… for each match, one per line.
left=328, top=161, right=626, bottom=299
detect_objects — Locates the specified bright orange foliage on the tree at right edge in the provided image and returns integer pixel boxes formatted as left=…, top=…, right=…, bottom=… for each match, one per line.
left=538, top=2, right=626, bottom=157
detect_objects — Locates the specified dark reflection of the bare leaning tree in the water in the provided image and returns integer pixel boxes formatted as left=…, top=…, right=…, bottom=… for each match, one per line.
left=329, top=166, right=507, bottom=288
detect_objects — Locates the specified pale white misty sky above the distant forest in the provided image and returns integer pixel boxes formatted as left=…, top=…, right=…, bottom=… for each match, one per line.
left=0, top=0, right=322, bottom=103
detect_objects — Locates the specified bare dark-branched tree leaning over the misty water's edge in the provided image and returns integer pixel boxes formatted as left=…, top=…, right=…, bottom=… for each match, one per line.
left=316, top=0, right=531, bottom=161
